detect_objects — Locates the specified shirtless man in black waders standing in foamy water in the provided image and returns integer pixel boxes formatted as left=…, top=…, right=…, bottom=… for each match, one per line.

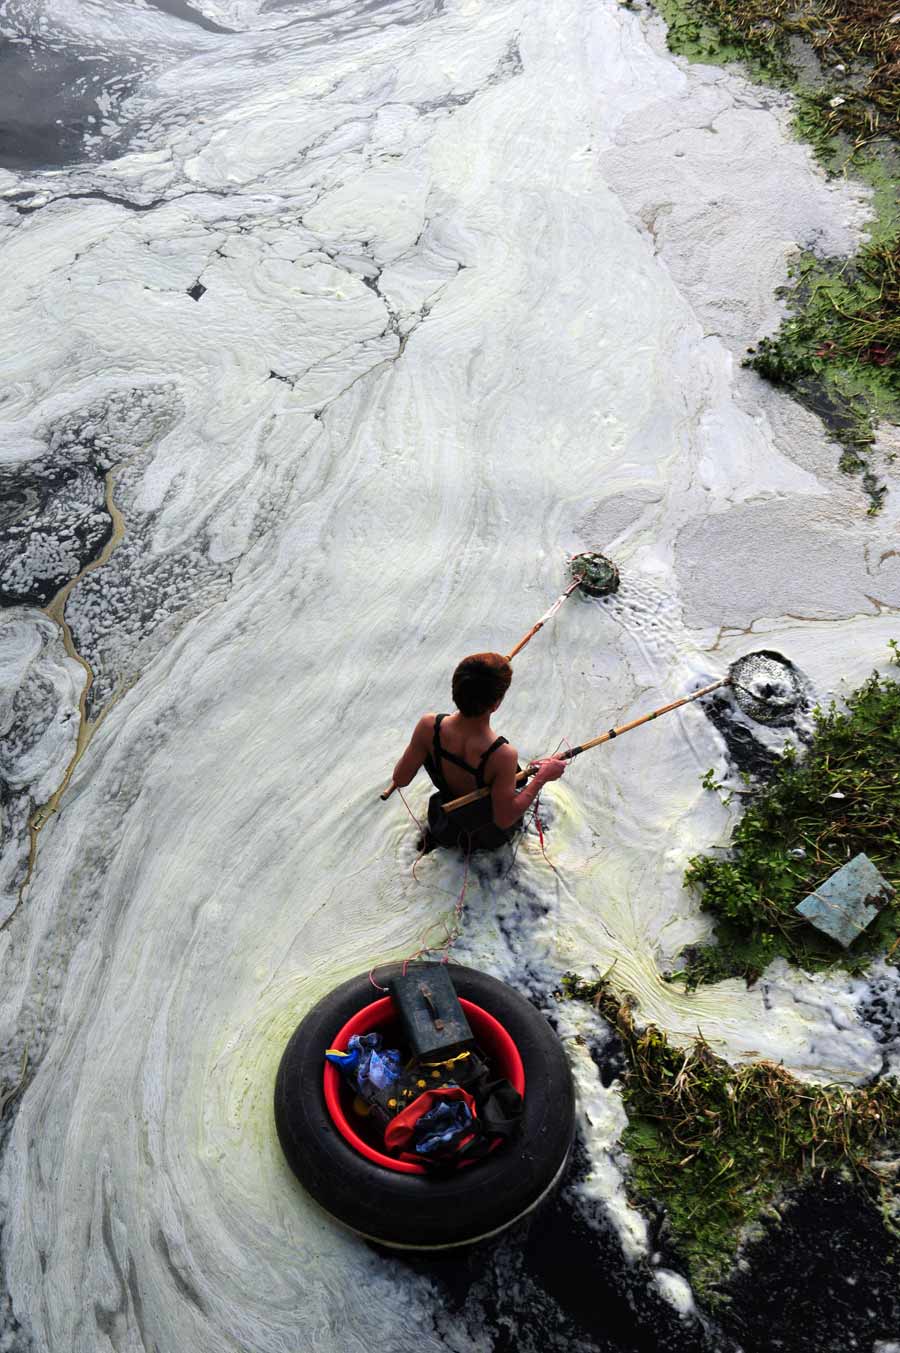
left=394, top=653, right=566, bottom=851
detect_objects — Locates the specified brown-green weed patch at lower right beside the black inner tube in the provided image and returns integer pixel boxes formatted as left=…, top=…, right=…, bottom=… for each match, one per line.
left=563, top=973, right=900, bottom=1304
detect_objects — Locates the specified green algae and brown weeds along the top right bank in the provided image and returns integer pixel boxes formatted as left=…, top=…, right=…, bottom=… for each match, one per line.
left=646, top=0, right=900, bottom=513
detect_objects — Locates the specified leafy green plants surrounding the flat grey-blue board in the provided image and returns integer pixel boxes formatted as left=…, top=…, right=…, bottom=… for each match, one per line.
left=673, top=644, right=900, bottom=986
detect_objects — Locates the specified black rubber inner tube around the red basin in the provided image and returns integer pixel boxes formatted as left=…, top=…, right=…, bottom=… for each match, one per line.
left=275, top=965, right=575, bottom=1250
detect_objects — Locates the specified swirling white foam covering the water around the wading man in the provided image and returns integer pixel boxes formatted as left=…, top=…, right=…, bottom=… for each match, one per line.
left=0, top=0, right=900, bottom=1353
